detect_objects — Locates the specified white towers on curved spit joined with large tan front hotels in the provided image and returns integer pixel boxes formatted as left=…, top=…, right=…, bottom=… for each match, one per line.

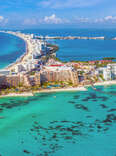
left=0, top=31, right=78, bottom=87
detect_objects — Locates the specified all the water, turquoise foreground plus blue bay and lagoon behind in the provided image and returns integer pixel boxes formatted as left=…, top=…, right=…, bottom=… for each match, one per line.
left=0, top=30, right=116, bottom=156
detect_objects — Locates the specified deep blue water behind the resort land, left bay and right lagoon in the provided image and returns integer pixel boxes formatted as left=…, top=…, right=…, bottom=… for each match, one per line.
left=0, top=29, right=116, bottom=69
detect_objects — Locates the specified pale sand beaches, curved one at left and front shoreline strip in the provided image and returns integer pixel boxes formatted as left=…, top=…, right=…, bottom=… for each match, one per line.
left=0, top=32, right=116, bottom=97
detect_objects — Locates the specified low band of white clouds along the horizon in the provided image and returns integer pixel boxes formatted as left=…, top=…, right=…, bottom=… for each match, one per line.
left=21, top=14, right=116, bottom=26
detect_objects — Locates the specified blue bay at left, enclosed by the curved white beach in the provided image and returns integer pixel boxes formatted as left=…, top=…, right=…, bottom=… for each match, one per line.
left=0, top=33, right=25, bottom=69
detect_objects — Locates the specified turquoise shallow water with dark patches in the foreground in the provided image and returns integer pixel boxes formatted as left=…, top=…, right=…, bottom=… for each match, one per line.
left=0, top=86, right=116, bottom=156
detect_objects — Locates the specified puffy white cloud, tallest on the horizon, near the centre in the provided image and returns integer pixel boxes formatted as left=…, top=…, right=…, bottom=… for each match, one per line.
left=43, top=14, right=63, bottom=24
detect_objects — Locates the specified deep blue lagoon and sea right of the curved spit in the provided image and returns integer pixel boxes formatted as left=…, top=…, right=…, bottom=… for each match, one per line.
left=23, top=29, right=116, bottom=61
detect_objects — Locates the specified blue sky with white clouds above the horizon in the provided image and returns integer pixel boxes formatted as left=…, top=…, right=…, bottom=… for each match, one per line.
left=0, top=0, right=116, bottom=29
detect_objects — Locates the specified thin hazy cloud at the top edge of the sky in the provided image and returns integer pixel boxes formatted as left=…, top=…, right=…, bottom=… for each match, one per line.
left=38, top=0, right=101, bottom=9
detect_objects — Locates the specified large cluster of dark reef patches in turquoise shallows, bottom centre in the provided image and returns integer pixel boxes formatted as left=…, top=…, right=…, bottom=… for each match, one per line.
left=30, top=120, right=86, bottom=156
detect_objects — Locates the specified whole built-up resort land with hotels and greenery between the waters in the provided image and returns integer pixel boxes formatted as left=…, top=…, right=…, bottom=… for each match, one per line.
left=0, top=31, right=116, bottom=94
